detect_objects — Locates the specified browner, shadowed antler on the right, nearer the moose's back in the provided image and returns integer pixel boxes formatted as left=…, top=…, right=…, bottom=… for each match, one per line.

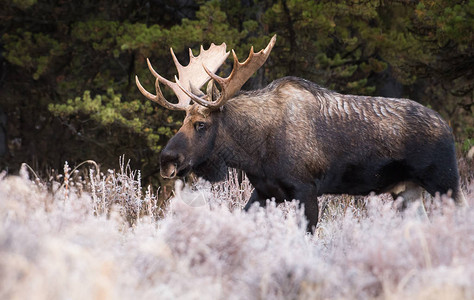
left=176, top=35, right=276, bottom=109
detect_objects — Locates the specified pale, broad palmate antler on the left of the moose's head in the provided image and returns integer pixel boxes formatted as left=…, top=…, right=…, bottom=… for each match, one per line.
left=135, top=43, right=229, bottom=110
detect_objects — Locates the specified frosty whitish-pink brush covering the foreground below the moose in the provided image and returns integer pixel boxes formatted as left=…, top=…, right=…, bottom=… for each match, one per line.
left=0, top=161, right=474, bottom=299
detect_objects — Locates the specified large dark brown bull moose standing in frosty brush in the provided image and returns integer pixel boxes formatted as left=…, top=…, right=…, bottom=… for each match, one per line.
left=136, top=35, right=466, bottom=231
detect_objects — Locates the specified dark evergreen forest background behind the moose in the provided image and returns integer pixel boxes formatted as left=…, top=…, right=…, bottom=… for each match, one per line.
left=0, top=0, right=474, bottom=188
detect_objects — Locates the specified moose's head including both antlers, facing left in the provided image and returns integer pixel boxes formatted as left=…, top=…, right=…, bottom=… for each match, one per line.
left=136, top=36, right=276, bottom=179
